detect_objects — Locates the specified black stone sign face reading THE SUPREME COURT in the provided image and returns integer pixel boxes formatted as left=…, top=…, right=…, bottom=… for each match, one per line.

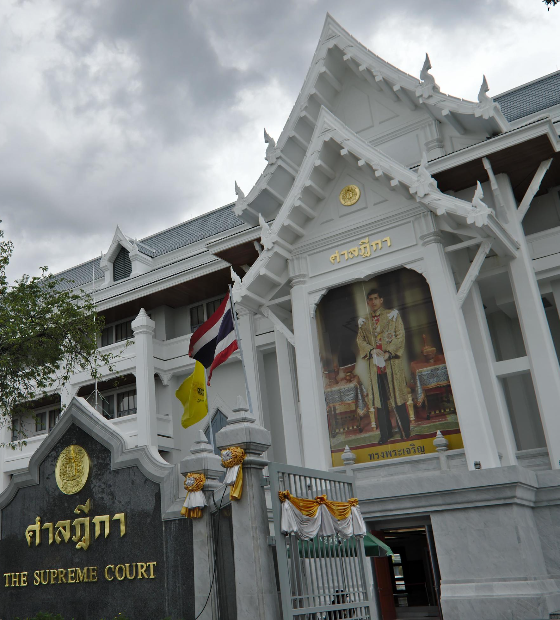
left=0, top=423, right=194, bottom=620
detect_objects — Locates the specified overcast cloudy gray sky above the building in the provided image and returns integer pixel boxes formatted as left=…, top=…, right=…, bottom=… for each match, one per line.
left=0, top=0, right=560, bottom=278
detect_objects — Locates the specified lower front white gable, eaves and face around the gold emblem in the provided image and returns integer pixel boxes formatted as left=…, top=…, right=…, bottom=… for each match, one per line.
left=234, top=108, right=517, bottom=310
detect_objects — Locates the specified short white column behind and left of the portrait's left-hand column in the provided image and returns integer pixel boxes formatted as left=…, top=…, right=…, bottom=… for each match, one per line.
left=274, top=329, right=303, bottom=465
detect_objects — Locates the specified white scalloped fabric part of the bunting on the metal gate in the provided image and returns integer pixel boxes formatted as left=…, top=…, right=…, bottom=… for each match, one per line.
left=280, top=500, right=367, bottom=540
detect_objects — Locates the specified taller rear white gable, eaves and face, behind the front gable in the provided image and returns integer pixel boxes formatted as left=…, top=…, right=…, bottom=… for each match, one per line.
left=235, top=15, right=509, bottom=224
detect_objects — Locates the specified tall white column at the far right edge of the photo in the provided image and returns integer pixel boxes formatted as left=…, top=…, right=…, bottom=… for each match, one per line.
left=497, top=174, right=560, bottom=469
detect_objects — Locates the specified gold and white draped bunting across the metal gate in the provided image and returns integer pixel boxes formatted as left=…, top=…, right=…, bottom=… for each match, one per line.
left=278, top=491, right=366, bottom=540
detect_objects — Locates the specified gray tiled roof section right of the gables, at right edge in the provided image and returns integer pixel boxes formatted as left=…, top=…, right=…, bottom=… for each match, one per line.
left=494, top=71, right=560, bottom=121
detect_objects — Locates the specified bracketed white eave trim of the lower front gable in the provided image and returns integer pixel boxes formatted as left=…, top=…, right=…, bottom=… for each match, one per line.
left=234, top=108, right=519, bottom=311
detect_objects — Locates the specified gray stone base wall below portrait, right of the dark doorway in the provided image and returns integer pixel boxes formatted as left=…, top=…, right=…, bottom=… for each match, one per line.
left=352, top=455, right=560, bottom=620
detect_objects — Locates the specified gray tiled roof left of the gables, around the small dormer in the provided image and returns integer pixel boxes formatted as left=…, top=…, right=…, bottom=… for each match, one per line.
left=56, top=203, right=245, bottom=289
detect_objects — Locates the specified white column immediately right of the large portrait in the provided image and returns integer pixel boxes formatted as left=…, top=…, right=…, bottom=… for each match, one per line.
left=417, top=214, right=500, bottom=470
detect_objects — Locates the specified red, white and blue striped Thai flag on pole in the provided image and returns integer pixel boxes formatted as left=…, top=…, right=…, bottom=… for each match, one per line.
left=189, top=293, right=237, bottom=385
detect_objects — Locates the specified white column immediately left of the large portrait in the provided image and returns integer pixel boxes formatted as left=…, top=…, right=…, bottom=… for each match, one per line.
left=290, top=259, right=332, bottom=470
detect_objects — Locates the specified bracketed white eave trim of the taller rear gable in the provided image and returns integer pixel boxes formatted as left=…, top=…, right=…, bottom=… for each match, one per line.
left=235, top=15, right=509, bottom=225
